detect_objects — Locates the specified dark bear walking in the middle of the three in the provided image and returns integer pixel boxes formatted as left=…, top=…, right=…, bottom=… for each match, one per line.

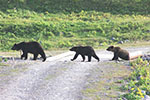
left=70, top=46, right=100, bottom=62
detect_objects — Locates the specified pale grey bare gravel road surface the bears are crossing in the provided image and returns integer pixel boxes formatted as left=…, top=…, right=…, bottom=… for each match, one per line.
left=0, top=47, right=150, bottom=100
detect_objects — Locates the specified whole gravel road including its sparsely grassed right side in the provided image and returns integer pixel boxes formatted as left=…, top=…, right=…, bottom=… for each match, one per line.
left=0, top=47, right=150, bottom=100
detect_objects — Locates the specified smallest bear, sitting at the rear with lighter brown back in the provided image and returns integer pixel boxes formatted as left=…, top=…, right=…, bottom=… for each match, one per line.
left=106, top=46, right=130, bottom=60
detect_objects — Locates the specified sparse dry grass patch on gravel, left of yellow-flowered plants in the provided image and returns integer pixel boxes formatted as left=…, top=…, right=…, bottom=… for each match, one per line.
left=82, top=62, right=130, bottom=100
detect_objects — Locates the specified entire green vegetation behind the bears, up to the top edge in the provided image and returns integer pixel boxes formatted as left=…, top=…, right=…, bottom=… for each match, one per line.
left=0, top=0, right=150, bottom=51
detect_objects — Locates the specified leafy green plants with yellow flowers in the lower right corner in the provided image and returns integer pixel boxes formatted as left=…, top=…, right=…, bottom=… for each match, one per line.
left=123, top=58, right=150, bottom=100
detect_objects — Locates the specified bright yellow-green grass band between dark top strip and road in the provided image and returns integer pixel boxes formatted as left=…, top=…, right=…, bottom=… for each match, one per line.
left=0, top=9, right=150, bottom=51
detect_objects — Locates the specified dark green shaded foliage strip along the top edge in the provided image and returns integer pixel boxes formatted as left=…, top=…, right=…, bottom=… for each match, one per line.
left=0, top=0, right=150, bottom=14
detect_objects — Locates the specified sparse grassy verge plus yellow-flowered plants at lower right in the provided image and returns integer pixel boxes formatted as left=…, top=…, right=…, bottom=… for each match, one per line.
left=82, top=58, right=150, bottom=100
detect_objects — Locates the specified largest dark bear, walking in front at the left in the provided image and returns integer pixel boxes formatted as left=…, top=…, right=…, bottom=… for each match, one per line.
left=11, top=41, right=46, bottom=61
